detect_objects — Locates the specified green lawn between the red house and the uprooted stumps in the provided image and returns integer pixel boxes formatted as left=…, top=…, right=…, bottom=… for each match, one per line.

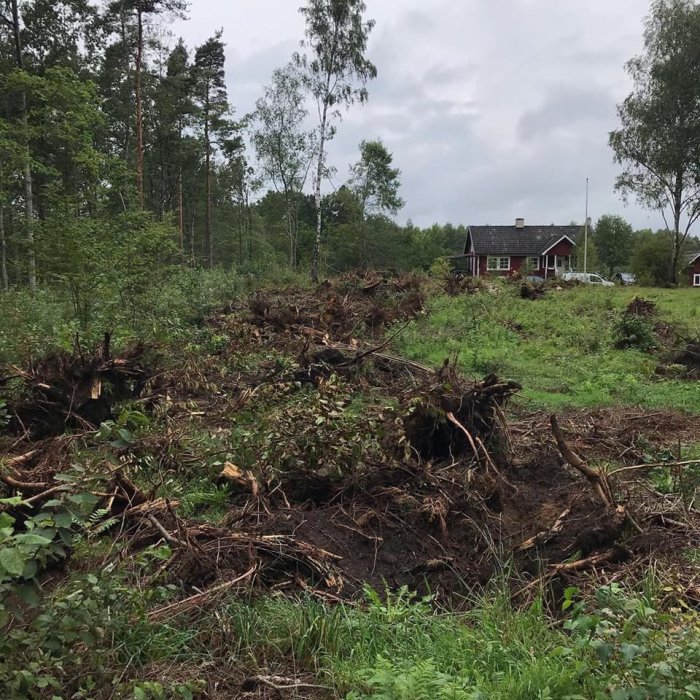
left=396, top=283, right=700, bottom=414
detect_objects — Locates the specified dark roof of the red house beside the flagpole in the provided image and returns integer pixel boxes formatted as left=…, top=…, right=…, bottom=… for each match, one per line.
left=464, top=226, right=581, bottom=256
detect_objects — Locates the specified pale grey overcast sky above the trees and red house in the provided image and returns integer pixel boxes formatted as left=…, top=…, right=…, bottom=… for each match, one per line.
left=172, top=0, right=661, bottom=228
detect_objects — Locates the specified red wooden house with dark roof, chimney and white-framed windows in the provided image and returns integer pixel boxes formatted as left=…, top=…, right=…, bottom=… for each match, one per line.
left=452, top=219, right=581, bottom=277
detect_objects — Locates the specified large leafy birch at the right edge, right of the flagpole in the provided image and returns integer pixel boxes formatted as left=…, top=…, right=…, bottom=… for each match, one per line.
left=609, top=0, right=700, bottom=283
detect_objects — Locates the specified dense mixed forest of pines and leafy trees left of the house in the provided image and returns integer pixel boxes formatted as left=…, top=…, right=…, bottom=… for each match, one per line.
left=0, top=0, right=463, bottom=296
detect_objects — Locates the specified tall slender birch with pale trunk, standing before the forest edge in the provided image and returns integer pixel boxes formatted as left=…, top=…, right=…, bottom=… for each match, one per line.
left=294, top=0, right=377, bottom=282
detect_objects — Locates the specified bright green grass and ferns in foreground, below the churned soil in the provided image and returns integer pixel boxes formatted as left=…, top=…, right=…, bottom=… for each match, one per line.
left=204, top=588, right=699, bottom=700
